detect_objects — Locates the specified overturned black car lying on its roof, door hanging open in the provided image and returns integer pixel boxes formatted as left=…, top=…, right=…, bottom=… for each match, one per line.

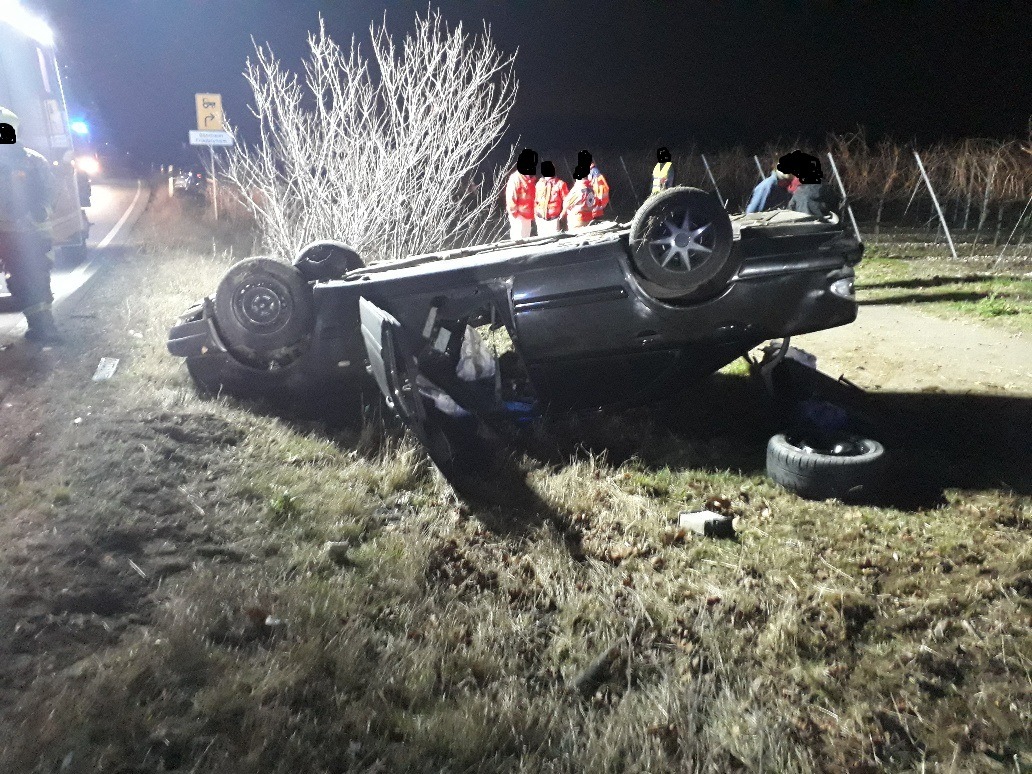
left=168, top=188, right=863, bottom=473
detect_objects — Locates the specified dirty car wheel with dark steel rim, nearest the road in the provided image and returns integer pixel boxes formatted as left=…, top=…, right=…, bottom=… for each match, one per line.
left=215, top=257, right=315, bottom=359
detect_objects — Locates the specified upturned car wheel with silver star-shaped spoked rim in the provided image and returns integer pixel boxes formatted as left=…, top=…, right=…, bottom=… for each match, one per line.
left=630, top=187, right=740, bottom=298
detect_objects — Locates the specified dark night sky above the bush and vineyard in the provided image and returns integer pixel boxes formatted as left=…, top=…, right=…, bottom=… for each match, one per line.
left=27, top=0, right=1032, bottom=162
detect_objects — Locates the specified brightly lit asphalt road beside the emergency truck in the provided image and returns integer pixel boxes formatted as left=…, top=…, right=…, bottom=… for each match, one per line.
left=0, top=181, right=148, bottom=346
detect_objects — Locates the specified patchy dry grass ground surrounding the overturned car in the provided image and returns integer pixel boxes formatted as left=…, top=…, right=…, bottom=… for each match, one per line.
left=0, top=195, right=1032, bottom=774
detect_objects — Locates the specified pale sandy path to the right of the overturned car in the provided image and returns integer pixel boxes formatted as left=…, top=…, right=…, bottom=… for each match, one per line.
left=792, top=305, right=1032, bottom=395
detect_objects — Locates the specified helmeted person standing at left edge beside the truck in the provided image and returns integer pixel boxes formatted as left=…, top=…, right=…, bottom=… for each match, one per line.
left=0, top=107, right=61, bottom=344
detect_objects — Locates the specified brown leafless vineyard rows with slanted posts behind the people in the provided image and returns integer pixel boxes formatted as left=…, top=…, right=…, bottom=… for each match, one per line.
left=541, top=132, right=1032, bottom=254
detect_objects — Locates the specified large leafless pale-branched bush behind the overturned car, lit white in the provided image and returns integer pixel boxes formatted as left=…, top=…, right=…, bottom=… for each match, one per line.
left=226, top=11, right=517, bottom=263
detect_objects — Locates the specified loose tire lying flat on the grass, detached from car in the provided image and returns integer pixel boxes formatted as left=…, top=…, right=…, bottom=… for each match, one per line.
left=767, top=433, right=885, bottom=501
